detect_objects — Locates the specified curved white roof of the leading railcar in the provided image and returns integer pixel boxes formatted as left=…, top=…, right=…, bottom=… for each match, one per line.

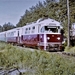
left=23, top=18, right=63, bottom=28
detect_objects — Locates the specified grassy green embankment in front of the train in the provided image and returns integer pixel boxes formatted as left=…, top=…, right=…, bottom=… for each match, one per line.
left=0, top=43, right=75, bottom=75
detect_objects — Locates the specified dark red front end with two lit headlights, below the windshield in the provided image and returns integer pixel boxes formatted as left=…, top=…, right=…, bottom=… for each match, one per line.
left=46, top=34, right=61, bottom=51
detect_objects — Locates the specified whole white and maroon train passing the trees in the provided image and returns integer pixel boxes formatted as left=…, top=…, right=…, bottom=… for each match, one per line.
left=0, top=18, right=63, bottom=51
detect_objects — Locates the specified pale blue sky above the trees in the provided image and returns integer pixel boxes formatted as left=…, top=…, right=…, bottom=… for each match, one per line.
left=0, top=0, right=44, bottom=25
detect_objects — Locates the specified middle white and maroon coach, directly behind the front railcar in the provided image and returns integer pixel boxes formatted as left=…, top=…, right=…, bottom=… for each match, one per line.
left=6, top=27, right=21, bottom=44
